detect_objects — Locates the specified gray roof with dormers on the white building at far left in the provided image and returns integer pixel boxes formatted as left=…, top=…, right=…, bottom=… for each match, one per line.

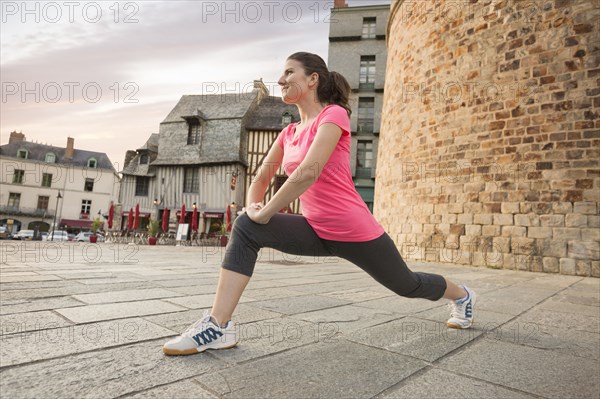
left=0, top=141, right=117, bottom=173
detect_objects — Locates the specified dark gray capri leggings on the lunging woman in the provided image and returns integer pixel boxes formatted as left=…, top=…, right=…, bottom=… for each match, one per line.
left=222, top=213, right=446, bottom=301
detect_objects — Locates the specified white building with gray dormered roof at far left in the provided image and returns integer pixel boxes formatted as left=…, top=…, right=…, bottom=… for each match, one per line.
left=0, top=132, right=120, bottom=233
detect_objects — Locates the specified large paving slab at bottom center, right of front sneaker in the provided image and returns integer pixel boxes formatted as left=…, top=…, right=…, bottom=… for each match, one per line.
left=195, top=341, right=426, bottom=399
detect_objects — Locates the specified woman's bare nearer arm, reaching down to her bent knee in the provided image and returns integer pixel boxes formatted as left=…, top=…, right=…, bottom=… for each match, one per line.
left=248, top=123, right=342, bottom=224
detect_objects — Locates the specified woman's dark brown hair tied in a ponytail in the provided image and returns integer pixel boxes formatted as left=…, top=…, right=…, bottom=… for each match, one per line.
left=288, top=52, right=352, bottom=116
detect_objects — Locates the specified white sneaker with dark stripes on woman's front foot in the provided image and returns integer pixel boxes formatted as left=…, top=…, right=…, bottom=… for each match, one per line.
left=163, top=310, right=238, bottom=355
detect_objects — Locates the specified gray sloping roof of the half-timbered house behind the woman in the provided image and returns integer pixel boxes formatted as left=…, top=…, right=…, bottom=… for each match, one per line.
left=162, top=90, right=257, bottom=123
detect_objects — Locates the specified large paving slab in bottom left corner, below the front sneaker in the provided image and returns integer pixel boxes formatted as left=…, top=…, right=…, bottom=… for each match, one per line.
left=0, top=340, right=223, bottom=398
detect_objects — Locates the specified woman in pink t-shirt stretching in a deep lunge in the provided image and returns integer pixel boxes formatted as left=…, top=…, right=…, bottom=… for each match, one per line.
left=163, top=52, right=476, bottom=355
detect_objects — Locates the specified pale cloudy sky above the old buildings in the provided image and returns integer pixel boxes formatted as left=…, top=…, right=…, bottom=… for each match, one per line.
left=0, top=0, right=390, bottom=170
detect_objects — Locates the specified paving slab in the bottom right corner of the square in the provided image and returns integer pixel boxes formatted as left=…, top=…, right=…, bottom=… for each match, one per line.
left=438, top=340, right=600, bottom=398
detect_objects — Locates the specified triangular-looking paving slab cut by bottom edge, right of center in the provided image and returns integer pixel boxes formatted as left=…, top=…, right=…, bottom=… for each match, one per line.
left=378, top=368, right=538, bottom=399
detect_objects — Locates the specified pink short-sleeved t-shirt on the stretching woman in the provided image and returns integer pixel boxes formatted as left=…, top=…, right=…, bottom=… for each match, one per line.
left=277, top=105, right=384, bottom=242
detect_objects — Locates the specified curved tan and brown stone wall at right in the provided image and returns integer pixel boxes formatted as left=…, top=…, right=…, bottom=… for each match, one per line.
left=374, top=0, right=600, bottom=277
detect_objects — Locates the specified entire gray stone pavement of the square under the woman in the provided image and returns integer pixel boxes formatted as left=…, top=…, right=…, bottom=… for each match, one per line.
left=0, top=241, right=600, bottom=399
